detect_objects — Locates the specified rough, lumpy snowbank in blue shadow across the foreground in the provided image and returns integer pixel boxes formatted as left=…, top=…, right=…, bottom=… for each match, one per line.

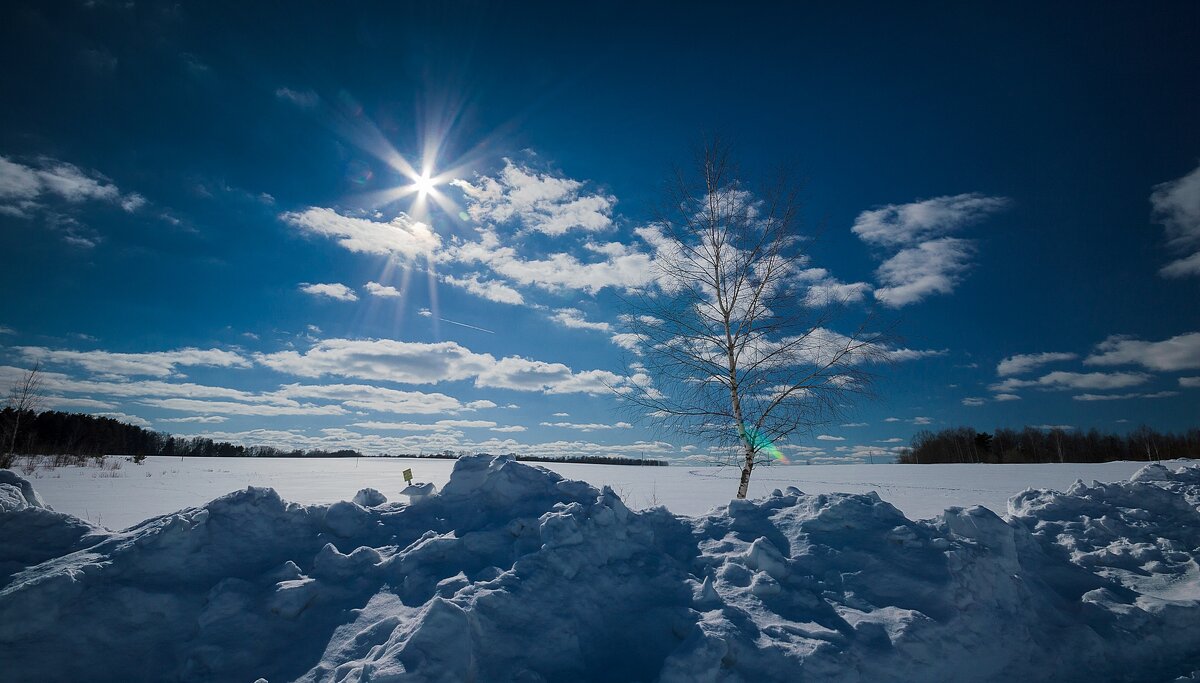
left=0, top=457, right=1200, bottom=683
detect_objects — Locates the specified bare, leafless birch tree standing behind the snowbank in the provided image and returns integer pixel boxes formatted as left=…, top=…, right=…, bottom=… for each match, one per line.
left=622, top=143, right=884, bottom=498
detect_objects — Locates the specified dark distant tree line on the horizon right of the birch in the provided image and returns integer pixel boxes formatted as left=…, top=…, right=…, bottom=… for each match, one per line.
left=896, top=426, right=1200, bottom=465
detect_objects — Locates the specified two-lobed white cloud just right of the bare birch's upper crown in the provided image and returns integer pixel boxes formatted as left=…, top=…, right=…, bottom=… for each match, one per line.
left=851, top=193, right=1009, bottom=307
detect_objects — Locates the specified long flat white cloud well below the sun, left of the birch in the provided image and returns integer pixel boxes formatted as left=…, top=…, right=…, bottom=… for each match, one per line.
left=254, top=338, right=626, bottom=394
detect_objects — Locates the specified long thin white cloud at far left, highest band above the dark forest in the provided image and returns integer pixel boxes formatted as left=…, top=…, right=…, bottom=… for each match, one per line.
left=17, top=346, right=251, bottom=377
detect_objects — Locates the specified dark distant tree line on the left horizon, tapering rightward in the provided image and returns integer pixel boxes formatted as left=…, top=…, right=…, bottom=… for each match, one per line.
left=0, top=407, right=667, bottom=467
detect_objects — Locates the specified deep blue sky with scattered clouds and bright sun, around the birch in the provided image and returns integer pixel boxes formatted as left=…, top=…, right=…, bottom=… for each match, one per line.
left=0, top=1, right=1200, bottom=462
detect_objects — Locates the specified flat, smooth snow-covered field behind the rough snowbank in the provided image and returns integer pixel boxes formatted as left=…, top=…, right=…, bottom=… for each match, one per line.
left=7, top=457, right=1145, bottom=529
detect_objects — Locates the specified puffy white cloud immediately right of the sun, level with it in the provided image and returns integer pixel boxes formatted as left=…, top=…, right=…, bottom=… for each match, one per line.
left=451, top=160, right=617, bottom=235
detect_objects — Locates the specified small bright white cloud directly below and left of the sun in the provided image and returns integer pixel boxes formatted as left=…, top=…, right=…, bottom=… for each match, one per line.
left=280, top=206, right=442, bottom=258
